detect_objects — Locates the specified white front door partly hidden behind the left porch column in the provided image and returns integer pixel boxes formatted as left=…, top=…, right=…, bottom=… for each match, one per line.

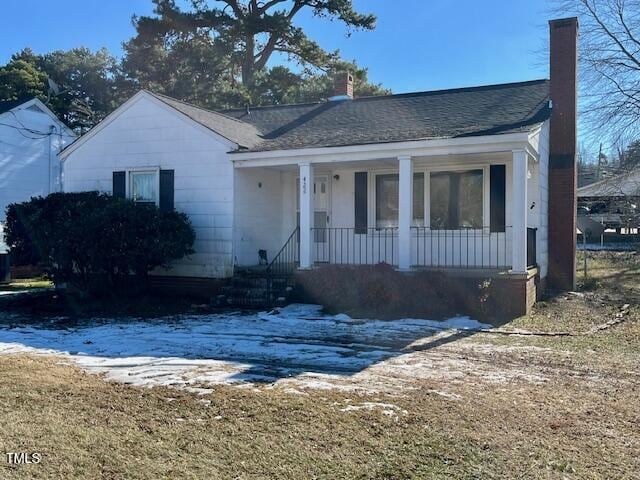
left=296, top=175, right=331, bottom=262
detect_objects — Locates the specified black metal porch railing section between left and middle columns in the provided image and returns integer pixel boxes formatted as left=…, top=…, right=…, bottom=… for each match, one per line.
left=311, top=227, right=398, bottom=265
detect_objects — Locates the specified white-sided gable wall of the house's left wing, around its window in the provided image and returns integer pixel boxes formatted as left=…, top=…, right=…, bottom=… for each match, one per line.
left=63, top=96, right=234, bottom=278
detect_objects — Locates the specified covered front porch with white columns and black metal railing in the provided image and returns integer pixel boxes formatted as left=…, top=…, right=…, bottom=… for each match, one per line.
left=235, top=134, right=546, bottom=275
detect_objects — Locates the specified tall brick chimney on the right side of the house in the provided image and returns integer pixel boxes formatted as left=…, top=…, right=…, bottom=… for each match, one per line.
left=547, top=17, right=578, bottom=290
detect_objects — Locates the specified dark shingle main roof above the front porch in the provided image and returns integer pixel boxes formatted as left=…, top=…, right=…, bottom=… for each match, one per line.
left=222, top=80, right=550, bottom=151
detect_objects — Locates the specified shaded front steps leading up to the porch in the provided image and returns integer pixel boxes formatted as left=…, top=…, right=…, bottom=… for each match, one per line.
left=215, top=270, right=293, bottom=308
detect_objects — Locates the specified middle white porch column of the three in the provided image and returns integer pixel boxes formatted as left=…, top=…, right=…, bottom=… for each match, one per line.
left=398, top=157, right=413, bottom=270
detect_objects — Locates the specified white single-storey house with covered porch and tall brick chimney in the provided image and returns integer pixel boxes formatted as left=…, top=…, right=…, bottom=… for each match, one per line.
left=62, top=19, right=577, bottom=313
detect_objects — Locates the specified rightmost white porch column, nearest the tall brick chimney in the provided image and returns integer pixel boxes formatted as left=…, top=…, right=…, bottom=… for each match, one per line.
left=511, top=150, right=529, bottom=273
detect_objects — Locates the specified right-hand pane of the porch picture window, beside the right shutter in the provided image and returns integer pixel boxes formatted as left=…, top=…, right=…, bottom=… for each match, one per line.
left=430, top=170, right=483, bottom=230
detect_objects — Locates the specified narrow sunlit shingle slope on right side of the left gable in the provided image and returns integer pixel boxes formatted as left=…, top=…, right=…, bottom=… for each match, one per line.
left=148, top=92, right=262, bottom=150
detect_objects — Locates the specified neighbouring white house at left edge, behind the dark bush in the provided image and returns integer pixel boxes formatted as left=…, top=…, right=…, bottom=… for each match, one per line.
left=0, top=98, right=76, bottom=250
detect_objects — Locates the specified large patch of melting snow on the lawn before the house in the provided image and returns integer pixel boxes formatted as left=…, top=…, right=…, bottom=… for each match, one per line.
left=0, top=304, right=539, bottom=393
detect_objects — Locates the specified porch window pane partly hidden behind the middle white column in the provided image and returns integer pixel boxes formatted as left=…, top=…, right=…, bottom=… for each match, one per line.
left=376, top=173, right=424, bottom=228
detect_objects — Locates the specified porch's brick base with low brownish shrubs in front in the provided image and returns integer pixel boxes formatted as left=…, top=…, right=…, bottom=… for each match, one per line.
left=294, top=264, right=543, bottom=322
